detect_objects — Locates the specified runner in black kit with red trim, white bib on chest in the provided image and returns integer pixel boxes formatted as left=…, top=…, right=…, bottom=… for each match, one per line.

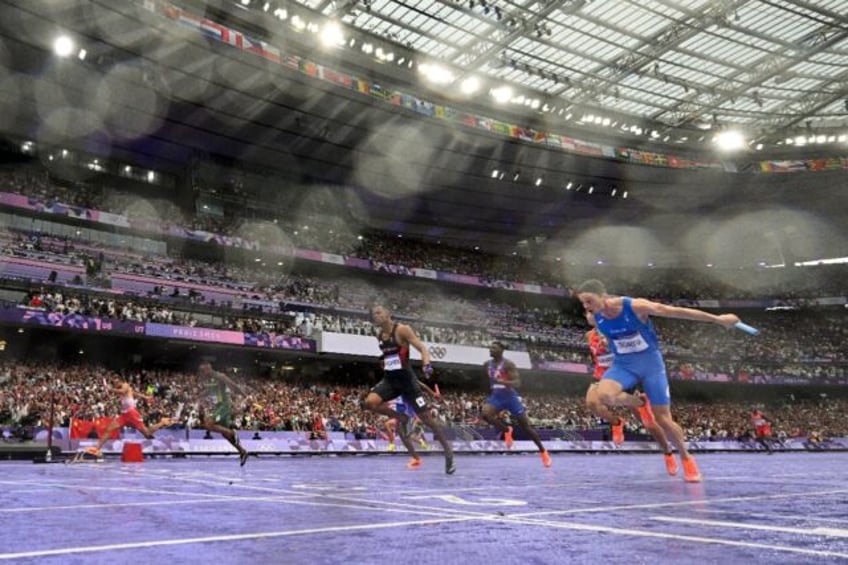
left=363, top=305, right=456, bottom=475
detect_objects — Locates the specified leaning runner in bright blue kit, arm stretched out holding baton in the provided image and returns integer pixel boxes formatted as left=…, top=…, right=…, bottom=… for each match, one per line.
left=576, top=279, right=739, bottom=483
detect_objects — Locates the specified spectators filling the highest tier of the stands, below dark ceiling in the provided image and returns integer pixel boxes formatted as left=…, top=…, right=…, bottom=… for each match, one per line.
left=0, top=163, right=846, bottom=305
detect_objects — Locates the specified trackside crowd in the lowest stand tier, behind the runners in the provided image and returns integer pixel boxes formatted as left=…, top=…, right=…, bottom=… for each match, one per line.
left=0, top=360, right=848, bottom=440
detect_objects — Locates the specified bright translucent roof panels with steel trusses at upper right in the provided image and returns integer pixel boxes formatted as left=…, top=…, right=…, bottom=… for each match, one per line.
left=296, top=0, right=848, bottom=138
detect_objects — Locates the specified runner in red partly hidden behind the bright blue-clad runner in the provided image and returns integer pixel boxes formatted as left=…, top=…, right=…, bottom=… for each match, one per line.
left=586, top=312, right=678, bottom=476
